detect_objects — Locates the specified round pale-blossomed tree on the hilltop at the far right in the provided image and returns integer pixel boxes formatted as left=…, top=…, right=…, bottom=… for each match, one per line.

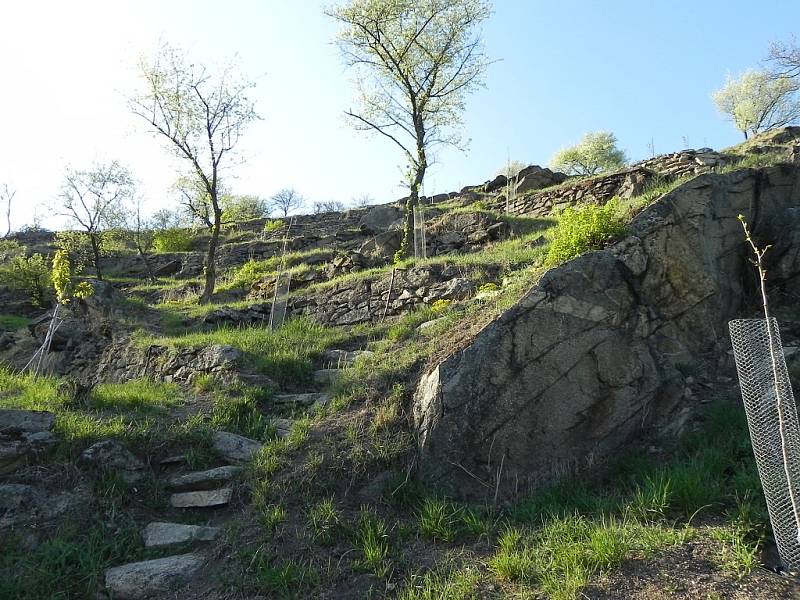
left=713, top=70, right=800, bottom=139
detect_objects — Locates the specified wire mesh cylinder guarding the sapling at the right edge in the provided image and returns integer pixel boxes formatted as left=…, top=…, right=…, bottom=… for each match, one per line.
left=728, top=319, right=800, bottom=570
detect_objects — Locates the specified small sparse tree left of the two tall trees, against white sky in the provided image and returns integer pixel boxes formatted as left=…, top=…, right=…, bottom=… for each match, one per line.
left=57, top=161, right=135, bottom=279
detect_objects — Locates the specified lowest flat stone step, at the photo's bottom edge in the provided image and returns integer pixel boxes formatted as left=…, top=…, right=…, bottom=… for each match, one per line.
left=105, top=554, right=205, bottom=600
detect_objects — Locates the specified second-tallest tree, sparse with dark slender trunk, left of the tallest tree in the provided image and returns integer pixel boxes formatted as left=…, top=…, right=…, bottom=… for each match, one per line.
left=131, top=46, right=258, bottom=304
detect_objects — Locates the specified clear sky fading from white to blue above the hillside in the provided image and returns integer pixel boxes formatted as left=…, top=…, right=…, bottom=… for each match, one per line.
left=0, top=0, right=800, bottom=227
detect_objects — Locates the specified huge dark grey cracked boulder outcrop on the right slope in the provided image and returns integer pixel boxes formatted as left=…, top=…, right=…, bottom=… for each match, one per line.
left=414, top=165, right=800, bottom=497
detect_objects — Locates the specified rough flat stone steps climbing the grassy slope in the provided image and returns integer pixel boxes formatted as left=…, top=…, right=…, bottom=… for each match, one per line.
left=105, top=350, right=366, bottom=600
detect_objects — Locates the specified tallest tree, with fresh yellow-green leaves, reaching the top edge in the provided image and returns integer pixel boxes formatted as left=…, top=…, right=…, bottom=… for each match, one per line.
left=327, top=0, right=490, bottom=255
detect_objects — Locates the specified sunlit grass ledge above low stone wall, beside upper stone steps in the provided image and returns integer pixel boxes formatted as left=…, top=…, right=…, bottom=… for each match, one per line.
left=136, top=317, right=348, bottom=384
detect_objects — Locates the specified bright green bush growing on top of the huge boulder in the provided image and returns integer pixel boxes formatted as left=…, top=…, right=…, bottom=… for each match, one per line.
left=546, top=198, right=625, bottom=266
